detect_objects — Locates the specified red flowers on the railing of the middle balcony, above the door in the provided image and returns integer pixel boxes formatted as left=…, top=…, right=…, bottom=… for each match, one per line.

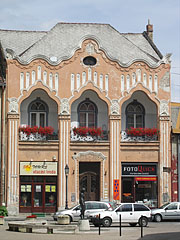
left=71, top=127, right=103, bottom=141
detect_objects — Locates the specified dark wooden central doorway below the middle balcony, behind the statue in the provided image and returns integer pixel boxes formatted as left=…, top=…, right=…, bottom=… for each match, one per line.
left=79, top=162, right=100, bottom=201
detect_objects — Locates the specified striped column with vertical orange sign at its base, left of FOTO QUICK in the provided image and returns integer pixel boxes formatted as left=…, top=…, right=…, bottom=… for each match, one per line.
left=109, top=100, right=121, bottom=201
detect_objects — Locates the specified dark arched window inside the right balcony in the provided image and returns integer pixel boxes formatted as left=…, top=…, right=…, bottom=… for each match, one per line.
left=126, top=100, right=145, bottom=128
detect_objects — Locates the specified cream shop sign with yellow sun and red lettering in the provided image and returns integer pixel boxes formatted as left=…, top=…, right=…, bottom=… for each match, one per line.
left=20, top=162, right=57, bottom=176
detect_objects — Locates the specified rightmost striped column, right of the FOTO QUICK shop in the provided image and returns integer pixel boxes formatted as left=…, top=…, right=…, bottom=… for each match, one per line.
left=159, top=100, right=171, bottom=205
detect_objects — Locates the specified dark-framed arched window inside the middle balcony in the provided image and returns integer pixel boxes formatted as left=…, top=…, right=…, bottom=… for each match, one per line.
left=78, top=98, right=97, bottom=127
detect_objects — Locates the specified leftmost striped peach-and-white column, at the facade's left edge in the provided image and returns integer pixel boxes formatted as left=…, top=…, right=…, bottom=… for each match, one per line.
left=6, top=98, right=19, bottom=215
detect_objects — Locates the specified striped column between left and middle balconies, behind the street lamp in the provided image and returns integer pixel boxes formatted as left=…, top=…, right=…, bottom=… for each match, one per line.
left=58, top=99, right=71, bottom=209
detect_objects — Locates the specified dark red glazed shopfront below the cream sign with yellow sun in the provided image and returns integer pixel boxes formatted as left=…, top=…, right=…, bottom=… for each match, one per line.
left=19, top=176, right=57, bottom=213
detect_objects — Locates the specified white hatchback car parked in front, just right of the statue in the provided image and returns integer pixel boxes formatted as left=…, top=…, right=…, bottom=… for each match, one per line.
left=89, top=203, right=151, bottom=227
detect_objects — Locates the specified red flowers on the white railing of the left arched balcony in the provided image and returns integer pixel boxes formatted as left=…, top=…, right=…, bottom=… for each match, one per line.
left=19, top=126, right=54, bottom=141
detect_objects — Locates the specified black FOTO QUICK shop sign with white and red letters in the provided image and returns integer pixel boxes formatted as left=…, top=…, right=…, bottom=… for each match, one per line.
left=122, top=164, right=157, bottom=176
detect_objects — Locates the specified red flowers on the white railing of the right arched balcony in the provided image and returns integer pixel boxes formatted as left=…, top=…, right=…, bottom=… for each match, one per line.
left=121, top=127, right=159, bottom=141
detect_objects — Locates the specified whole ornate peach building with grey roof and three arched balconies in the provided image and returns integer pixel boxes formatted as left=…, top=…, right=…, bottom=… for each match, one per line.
left=0, top=23, right=171, bottom=214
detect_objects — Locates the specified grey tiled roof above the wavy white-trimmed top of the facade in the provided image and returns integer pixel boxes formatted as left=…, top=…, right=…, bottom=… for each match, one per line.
left=0, top=23, right=161, bottom=65
